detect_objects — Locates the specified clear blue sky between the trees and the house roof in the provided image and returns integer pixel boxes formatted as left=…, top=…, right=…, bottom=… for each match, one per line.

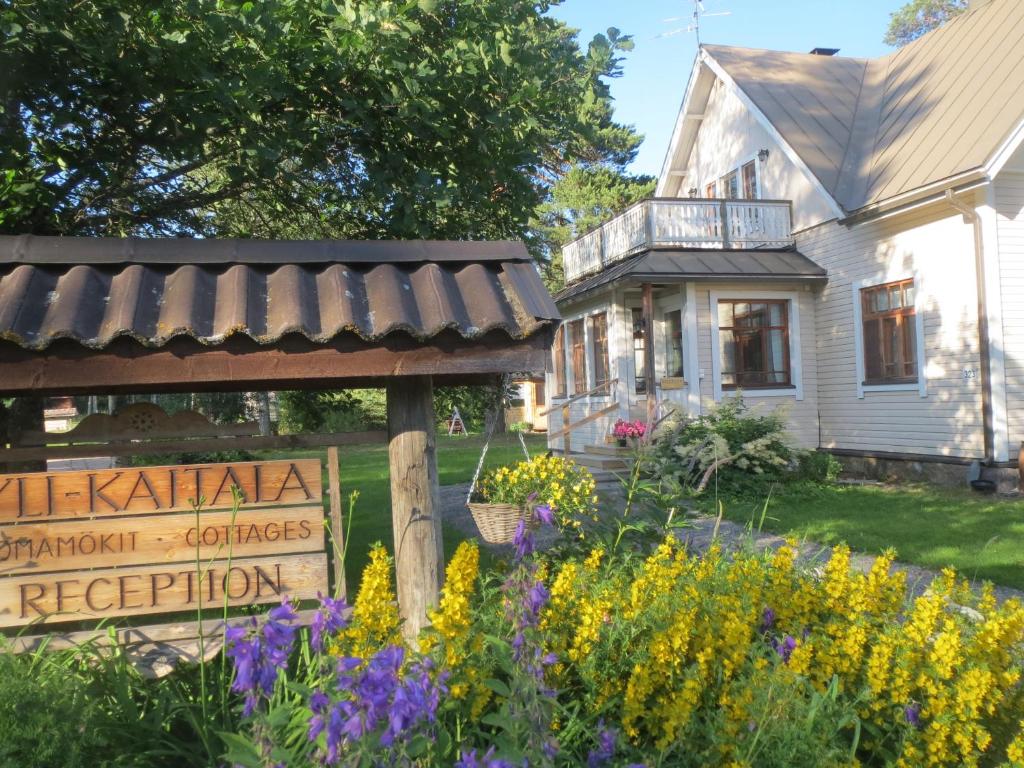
left=552, top=0, right=906, bottom=175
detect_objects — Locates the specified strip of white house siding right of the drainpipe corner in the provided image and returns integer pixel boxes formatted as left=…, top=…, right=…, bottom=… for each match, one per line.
left=995, top=172, right=1024, bottom=450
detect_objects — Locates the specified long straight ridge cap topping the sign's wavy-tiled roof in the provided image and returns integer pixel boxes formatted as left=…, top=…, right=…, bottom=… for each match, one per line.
left=0, top=234, right=532, bottom=266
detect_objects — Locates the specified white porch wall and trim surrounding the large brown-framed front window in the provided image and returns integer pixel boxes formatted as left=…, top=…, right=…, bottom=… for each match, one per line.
left=696, top=283, right=818, bottom=449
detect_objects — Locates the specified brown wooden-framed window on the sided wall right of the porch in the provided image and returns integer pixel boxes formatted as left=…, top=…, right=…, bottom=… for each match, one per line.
left=860, top=279, right=918, bottom=384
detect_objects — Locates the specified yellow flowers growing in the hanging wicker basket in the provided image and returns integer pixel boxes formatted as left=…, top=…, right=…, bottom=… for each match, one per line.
left=480, top=456, right=597, bottom=532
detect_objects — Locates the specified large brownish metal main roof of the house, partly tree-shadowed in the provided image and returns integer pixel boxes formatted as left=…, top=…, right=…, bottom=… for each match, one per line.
left=703, top=0, right=1024, bottom=211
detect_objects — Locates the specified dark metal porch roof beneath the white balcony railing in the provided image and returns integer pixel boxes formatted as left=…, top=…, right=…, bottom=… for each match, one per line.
left=555, top=249, right=827, bottom=301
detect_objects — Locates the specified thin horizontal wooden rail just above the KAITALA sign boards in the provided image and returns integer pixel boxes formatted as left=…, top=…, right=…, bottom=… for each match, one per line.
left=0, top=430, right=387, bottom=462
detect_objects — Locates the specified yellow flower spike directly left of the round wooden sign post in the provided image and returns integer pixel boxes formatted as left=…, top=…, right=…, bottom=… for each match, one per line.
left=331, top=544, right=398, bottom=658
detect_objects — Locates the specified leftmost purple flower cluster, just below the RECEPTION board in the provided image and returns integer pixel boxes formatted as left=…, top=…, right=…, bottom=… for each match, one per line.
left=224, top=598, right=298, bottom=717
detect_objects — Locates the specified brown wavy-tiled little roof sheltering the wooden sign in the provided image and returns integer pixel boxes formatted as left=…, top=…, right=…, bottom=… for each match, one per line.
left=0, top=236, right=559, bottom=350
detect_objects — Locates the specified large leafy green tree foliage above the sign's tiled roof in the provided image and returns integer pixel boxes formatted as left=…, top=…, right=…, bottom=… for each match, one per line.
left=0, top=0, right=637, bottom=239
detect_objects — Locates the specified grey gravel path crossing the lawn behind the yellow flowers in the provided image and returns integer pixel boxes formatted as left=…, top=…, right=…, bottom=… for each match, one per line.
left=440, top=483, right=1024, bottom=600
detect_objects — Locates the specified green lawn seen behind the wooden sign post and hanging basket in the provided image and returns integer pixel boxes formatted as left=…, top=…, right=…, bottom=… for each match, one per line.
left=260, top=433, right=547, bottom=599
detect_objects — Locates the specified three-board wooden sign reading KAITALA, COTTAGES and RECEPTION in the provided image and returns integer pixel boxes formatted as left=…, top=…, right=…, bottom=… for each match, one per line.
left=0, top=459, right=328, bottom=627
